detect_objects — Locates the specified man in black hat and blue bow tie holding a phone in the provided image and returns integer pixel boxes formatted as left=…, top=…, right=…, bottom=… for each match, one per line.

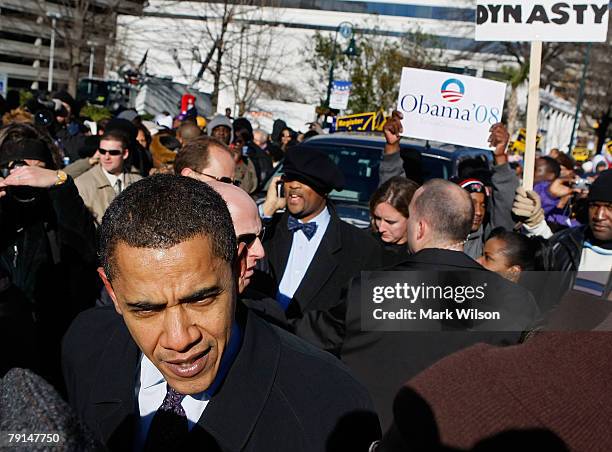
left=256, top=147, right=382, bottom=348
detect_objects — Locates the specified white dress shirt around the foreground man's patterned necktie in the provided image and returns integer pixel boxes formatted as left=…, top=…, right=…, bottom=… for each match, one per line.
left=135, top=354, right=210, bottom=450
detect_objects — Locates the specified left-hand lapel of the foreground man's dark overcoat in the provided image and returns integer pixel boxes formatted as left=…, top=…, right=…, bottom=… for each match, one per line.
left=92, top=321, right=140, bottom=449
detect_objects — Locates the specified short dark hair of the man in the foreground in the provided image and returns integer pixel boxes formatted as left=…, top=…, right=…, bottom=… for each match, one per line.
left=99, top=174, right=236, bottom=280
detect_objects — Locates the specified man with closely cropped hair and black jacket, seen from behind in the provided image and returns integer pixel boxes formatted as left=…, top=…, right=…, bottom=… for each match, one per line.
left=332, top=179, right=538, bottom=430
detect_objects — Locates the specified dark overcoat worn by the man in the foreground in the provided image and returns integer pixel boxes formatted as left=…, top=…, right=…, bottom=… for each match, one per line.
left=63, top=307, right=380, bottom=452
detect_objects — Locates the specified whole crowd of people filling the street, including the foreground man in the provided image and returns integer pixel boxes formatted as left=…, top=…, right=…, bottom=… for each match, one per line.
left=0, top=92, right=612, bottom=452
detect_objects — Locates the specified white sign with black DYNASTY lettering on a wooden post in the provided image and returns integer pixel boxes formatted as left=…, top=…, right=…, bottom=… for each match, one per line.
left=475, top=0, right=610, bottom=42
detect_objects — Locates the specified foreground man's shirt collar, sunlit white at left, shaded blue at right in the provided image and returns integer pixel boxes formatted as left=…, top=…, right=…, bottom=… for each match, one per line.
left=140, top=321, right=242, bottom=400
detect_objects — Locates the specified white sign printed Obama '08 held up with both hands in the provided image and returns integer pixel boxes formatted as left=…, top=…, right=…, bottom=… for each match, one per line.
left=397, top=68, right=506, bottom=149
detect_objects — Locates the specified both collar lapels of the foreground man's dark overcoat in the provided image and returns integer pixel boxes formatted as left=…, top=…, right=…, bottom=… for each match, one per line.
left=91, top=312, right=281, bottom=450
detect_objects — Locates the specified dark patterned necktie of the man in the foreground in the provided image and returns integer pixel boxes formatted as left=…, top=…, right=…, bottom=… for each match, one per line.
left=144, top=386, right=189, bottom=452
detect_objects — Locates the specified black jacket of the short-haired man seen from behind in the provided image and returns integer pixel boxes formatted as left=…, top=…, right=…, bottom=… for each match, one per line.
left=340, top=249, right=539, bottom=430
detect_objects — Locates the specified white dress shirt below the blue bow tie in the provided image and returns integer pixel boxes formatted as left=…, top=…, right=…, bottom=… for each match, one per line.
left=277, top=207, right=331, bottom=302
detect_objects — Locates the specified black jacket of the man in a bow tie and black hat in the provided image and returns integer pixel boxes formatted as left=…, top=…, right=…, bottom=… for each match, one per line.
left=255, top=205, right=382, bottom=320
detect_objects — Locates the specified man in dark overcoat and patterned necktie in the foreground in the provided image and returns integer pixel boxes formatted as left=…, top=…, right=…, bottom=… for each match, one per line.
left=63, top=175, right=380, bottom=452
